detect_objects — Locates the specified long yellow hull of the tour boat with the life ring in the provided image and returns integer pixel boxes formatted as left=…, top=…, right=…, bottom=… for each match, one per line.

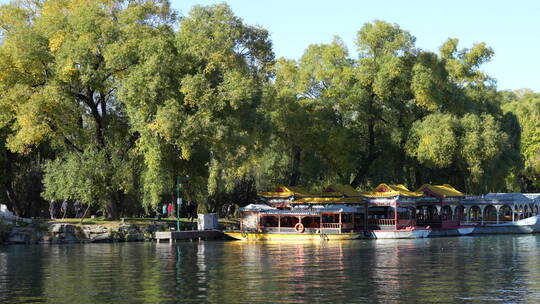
left=224, top=231, right=362, bottom=241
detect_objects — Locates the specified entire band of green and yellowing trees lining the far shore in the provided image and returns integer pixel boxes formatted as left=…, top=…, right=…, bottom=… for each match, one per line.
left=0, top=0, right=540, bottom=217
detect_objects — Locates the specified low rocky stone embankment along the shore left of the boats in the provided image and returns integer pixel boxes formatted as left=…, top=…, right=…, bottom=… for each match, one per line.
left=0, top=223, right=169, bottom=244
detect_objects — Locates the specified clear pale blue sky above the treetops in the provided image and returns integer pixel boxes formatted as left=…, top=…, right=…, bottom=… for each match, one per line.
left=0, top=0, right=540, bottom=92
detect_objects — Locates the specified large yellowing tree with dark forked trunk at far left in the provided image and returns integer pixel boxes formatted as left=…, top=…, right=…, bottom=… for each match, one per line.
left=0, top=0, right=174, bottom=217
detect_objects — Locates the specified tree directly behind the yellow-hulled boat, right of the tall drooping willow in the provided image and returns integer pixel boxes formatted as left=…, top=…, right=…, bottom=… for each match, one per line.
left=265, top=38, right=355, bottom=186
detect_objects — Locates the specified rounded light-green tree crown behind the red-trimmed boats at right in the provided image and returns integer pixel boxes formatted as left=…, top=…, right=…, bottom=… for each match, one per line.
left=407, top=114, right=507, bottom=193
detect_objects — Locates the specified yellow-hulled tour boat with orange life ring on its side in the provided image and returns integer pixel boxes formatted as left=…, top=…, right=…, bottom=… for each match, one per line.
left=224, top=204, right=364, bottom=241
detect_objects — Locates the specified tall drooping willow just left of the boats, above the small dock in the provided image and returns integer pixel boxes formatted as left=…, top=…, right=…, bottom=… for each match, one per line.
left=122, top=4, right=273, bottom=211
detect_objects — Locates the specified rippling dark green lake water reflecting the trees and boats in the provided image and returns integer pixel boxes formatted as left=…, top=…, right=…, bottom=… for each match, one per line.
left=0, top=235, right=540, bottom=303
